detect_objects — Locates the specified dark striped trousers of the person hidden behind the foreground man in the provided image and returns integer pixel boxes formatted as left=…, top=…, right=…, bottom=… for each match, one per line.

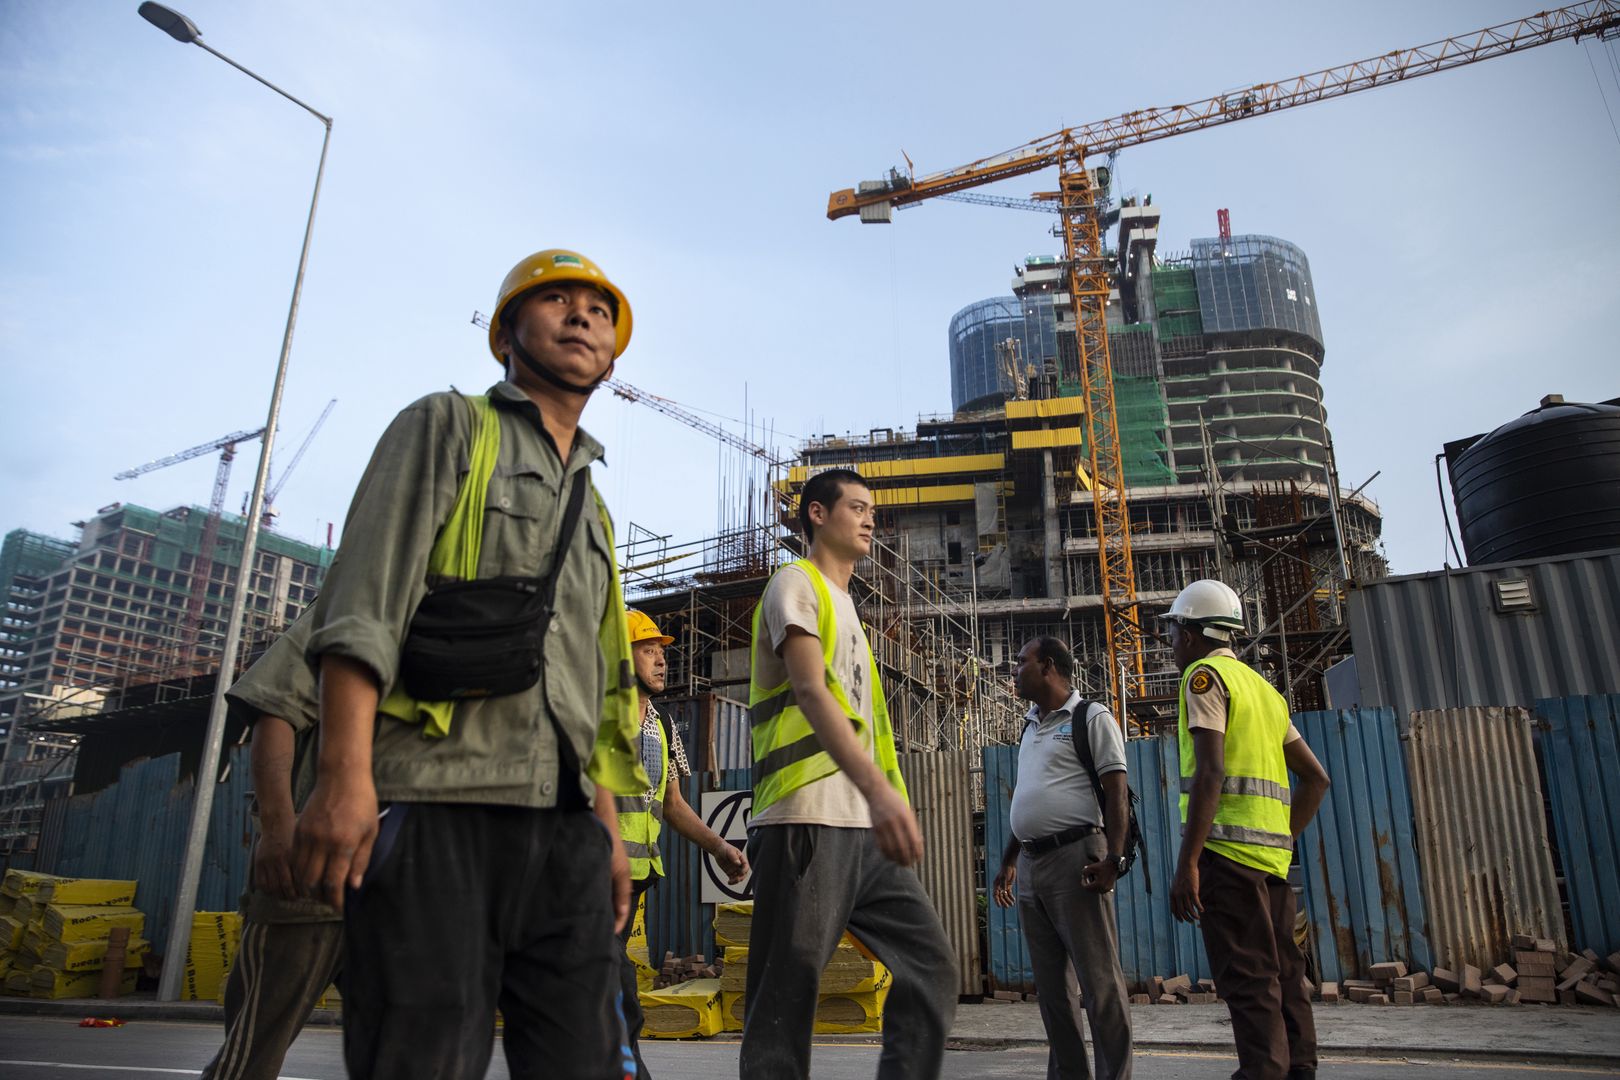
left=203, top=920, right=343, bottom=1080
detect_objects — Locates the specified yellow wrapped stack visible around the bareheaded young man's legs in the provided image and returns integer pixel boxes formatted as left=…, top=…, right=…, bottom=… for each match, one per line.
left=714, top=902, right=893, bottom=1035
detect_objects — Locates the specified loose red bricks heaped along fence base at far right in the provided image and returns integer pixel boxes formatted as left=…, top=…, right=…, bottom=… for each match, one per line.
left=1322, top=934, right=1620, bottom=1006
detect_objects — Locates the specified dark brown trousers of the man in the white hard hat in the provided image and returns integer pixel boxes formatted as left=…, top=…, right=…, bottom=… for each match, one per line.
left=1199, top=848, right=1317, bottom=1080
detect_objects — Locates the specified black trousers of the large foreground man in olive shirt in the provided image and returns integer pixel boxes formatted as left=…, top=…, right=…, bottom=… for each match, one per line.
left=343, top=803, right=635, bottom=1080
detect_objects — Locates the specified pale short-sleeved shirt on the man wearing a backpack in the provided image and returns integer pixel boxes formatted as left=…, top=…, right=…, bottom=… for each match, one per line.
left=1009, top=691, right=1126, bottom=840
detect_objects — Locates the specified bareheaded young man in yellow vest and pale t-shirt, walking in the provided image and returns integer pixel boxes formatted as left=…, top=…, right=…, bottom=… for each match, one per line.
left=739, top=470, right=956, bottom=1080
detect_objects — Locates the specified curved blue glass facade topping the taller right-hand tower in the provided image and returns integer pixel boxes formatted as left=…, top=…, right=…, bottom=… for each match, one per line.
left=1192, top=236, right=1322, bottom=347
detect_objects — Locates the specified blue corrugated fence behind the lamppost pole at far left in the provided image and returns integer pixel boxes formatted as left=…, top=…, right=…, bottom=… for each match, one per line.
left=37, top=746, right=253, bottom=954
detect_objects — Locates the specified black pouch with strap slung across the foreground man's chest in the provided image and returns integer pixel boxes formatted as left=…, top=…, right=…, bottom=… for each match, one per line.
left=400, top=470, right=586, bottom=701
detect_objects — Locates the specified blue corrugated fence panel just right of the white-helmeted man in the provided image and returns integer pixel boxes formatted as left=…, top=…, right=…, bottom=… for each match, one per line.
left=1294, top=708, right=1432, bottom=981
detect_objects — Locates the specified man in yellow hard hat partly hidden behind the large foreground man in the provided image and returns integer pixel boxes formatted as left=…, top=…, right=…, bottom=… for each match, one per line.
left=616, top=609, right=748, bottom=1080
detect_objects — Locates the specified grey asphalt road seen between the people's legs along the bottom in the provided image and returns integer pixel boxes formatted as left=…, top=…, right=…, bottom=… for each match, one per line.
left=0, top=1017, right=1620, bottom=1080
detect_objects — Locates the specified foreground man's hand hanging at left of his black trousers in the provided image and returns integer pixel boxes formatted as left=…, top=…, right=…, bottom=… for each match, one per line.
left=292, top=769, right=377, bottom=912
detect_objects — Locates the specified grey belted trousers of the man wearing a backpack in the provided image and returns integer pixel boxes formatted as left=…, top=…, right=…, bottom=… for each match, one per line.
left=1017, top=834, right=1131, bottom=1080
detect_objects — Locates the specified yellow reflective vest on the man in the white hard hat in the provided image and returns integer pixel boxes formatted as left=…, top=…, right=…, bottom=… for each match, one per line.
left=1178, top=656, right=1294, bottom=878
